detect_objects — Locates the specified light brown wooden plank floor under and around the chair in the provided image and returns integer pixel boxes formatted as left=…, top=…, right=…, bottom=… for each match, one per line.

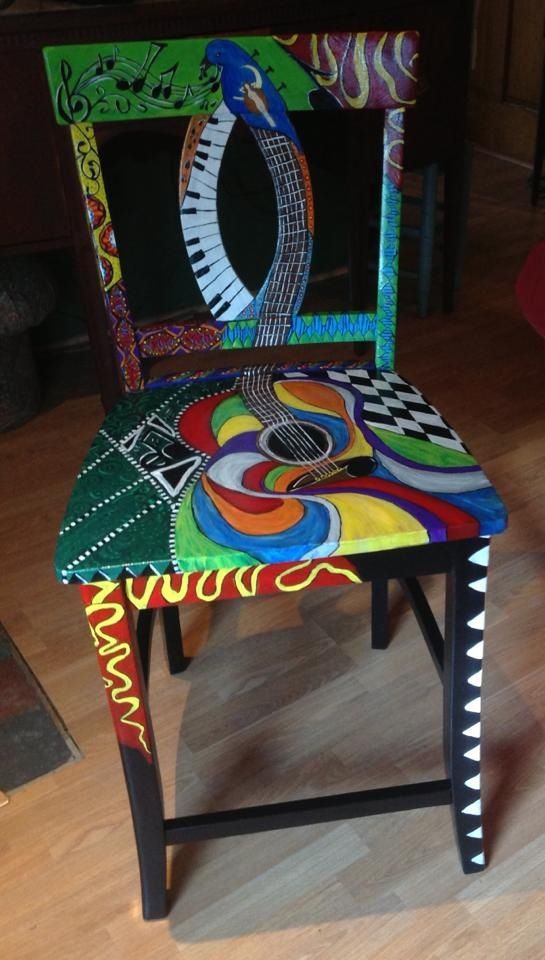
left=0, top=156, right=545, bottom=960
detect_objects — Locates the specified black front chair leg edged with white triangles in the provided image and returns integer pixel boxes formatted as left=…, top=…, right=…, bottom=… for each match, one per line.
left=444, top=538, right=489, bottom=873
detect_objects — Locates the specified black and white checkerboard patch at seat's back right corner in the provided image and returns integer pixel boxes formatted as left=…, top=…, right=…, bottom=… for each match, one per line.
left=328, top=367, right=467, bottom=452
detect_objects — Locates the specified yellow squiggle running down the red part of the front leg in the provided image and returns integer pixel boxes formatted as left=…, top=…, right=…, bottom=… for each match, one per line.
left=85, top=596, right=151, bottom=756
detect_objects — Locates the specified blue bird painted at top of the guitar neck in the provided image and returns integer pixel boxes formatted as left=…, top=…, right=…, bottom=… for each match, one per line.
left=205, top=40, right=301, bottom=150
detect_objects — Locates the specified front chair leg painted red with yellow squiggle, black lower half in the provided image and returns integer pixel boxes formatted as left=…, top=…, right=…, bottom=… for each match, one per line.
left=80, top=582, right=168, bottom=920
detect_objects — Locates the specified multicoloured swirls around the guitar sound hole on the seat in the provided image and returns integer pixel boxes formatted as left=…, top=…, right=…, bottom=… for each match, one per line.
left=176, top=371, right=488, bottom=569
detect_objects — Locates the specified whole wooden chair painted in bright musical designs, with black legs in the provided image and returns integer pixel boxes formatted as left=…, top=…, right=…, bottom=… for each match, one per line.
left=45, top=32, right=506, bottom=919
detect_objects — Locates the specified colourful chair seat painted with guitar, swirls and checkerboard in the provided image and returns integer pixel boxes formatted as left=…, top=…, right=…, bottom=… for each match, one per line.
left=56, top=365, right=506, bottom=583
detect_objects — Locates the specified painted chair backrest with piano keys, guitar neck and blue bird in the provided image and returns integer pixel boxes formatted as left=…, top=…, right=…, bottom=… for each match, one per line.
left=44, top=31, right=418, bottom=391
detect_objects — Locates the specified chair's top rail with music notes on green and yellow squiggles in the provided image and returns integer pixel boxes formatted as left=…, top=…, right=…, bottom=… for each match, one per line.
left=44, top=30, right=418, bottom=124
